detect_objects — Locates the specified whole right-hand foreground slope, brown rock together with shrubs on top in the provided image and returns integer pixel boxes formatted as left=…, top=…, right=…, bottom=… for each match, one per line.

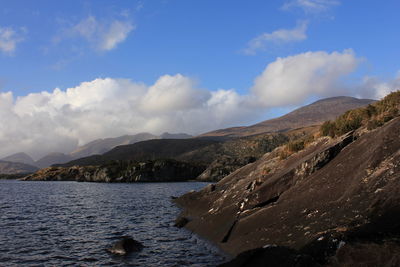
left=176, top=91, right=400, bottom=267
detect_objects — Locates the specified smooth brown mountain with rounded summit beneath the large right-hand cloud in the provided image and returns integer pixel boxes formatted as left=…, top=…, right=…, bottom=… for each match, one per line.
left=200, top=96, right=375, bottom=137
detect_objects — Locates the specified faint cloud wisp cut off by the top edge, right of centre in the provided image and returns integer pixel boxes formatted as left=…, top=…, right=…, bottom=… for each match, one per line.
left=282, top=0, right=340, bottom=13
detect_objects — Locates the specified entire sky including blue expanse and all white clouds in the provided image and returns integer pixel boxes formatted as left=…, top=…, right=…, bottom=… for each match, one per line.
left=0, top=0, right=400, bottom=158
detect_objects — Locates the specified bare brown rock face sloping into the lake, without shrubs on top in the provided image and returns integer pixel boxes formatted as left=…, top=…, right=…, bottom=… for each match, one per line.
left=176, top=118, right=400, bottom=266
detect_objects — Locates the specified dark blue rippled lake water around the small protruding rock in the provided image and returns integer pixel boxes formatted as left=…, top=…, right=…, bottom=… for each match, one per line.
left=0, top=181, right=224, bottom=266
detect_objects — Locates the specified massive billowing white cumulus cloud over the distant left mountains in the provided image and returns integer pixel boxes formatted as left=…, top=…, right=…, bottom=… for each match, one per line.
left=0, top=74, right=255, bottom=157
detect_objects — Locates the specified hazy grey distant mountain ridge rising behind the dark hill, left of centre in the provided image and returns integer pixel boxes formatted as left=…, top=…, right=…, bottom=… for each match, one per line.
left=70, top=133, right=159, bottom=159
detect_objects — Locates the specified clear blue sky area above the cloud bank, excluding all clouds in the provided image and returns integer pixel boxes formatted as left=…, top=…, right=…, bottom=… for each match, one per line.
left=0, top=0, right=400, bottom=95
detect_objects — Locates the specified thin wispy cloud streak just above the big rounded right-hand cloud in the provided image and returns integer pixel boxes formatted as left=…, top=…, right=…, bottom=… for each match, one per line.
left=244, top=21, right=308, bottom=55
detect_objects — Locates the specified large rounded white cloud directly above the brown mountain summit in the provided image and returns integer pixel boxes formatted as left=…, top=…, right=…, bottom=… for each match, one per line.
left=251, top=50, right=359, bottom=106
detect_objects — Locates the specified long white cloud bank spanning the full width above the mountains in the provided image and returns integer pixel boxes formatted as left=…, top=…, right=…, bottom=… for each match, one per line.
left=0, top=50, right=394, bottom=158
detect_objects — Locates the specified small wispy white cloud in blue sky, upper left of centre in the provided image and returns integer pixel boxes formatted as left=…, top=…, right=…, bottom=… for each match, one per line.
left=54, top=16, right=136, bottom=51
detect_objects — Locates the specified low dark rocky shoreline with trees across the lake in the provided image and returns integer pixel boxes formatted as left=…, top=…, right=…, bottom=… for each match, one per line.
left=22, top=160, right=205, bottom=182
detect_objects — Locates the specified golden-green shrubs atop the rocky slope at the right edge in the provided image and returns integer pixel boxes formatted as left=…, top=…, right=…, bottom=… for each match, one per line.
left=320, top=91, right=400, bottom=137
